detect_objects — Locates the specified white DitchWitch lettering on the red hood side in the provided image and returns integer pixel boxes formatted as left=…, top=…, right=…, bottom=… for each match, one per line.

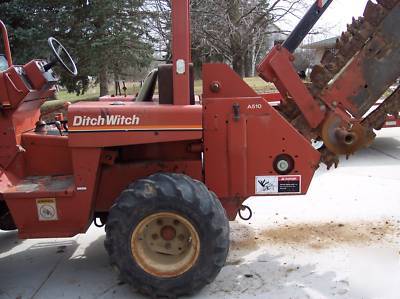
left=73, top=115, right=140, bottom=127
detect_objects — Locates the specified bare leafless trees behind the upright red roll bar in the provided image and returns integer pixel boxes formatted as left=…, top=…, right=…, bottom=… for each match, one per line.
left=144, top=0, right=306, bottom=76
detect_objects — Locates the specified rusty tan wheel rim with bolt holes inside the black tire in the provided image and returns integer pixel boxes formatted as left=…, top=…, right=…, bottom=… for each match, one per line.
left=131, top=212, right=200, bottom=278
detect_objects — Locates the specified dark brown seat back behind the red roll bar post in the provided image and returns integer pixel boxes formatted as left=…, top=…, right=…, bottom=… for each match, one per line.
left=158, top=63, right=195, bottom=105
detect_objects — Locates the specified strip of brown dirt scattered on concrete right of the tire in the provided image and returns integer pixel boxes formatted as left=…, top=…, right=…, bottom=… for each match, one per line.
left=231, top=220, right=400, bottom=251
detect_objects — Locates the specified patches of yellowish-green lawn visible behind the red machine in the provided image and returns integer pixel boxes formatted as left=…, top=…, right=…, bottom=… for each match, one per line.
left=42, top=77, right=275, bottom=111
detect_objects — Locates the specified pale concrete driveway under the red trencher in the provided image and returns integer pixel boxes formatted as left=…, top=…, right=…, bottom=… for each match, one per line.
left=0, top=129, right=400, bottom=299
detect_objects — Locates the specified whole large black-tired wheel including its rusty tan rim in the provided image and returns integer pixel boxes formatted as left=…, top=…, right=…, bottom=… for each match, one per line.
left=105, top=173, right=229, bottom=298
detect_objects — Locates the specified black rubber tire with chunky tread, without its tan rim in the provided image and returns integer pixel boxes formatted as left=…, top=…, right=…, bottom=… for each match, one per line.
left=105, top=173, right=229, bottom=298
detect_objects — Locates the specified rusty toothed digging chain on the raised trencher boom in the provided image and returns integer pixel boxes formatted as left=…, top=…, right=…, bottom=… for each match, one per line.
left=281, top=0, right=400, bottom=169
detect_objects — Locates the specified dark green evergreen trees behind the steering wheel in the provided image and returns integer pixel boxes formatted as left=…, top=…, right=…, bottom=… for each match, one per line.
left=0, top=0, right=153, bottom=95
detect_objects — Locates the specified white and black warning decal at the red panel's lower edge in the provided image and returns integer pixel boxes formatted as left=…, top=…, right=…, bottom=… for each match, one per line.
left=256, top=175, right=301, bottom=195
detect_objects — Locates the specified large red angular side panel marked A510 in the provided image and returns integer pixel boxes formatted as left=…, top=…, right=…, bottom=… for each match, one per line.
left=203, top=64, right=320, bottom=218
